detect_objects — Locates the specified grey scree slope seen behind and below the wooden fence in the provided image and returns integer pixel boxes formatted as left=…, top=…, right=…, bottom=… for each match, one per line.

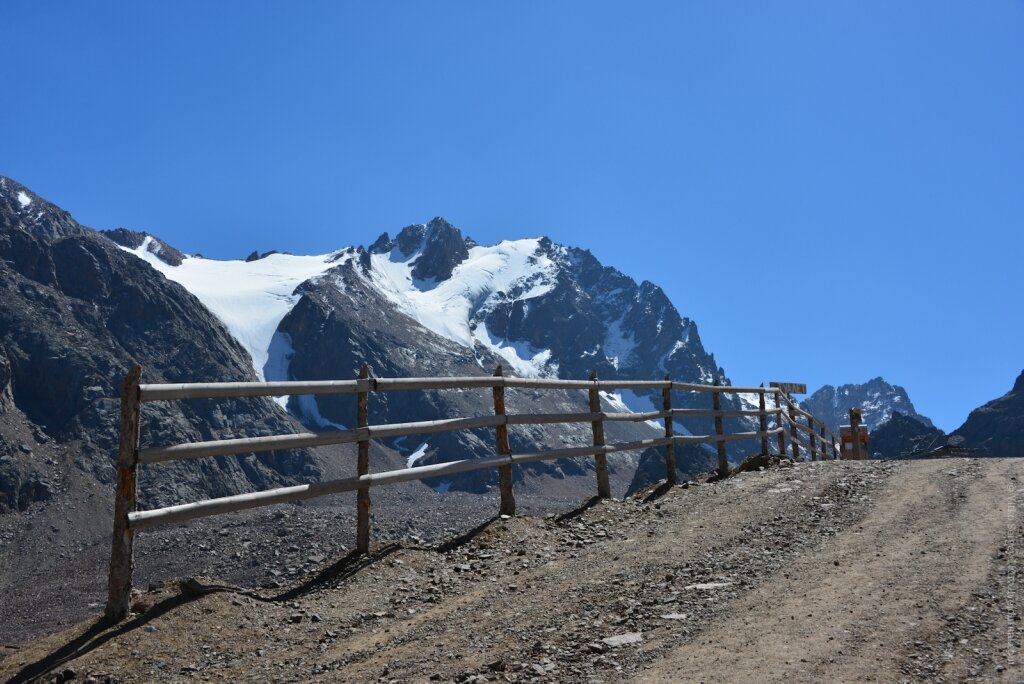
left=0, top=445, right=606, bottom=652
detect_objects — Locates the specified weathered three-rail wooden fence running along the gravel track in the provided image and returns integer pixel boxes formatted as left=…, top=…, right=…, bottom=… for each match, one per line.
left=105, top=366, right=839, bottom=622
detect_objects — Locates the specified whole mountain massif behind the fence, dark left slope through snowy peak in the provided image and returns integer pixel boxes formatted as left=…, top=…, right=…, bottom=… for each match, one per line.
left=0, top=178, right=757, bottom=508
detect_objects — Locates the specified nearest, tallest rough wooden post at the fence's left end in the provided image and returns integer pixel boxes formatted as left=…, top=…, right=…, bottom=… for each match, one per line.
left=104, top=366, right=142, bottom=623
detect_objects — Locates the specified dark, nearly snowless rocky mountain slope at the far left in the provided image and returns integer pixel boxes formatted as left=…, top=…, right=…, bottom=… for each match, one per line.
left=0, top=178, right=315, bottom=510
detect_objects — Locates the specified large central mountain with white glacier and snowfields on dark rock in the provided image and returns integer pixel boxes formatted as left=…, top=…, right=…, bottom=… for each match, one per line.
left=109, top=218, right=761, bottom=486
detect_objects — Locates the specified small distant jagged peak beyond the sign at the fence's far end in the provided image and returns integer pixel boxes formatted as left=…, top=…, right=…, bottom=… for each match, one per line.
left=800, top=377, right=934, bottom=434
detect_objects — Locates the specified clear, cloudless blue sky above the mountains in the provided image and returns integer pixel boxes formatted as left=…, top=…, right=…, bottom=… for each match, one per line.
left=0, top=0, right=1024, bottom=429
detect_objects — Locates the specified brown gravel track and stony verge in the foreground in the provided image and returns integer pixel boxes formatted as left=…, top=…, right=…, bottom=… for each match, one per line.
left=0, top=459, right=1024, bottom=682
